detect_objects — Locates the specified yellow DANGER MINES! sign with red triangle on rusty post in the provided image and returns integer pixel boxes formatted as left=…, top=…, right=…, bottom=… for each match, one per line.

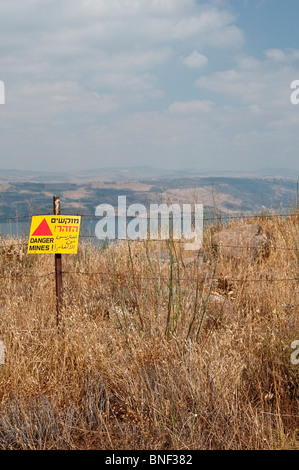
left=27, top=215, right=81, bottom=254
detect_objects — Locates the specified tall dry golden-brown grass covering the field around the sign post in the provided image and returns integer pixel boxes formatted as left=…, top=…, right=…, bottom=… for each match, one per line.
left=0, top=212, right=299, bottom=450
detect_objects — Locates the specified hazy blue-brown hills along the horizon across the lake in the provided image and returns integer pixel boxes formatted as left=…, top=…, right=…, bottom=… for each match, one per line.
left=0, top=167, right=298, bottom=217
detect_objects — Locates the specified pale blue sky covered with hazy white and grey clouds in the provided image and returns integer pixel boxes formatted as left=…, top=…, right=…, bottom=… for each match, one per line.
left=0, top=0, right=299, bottom=173
